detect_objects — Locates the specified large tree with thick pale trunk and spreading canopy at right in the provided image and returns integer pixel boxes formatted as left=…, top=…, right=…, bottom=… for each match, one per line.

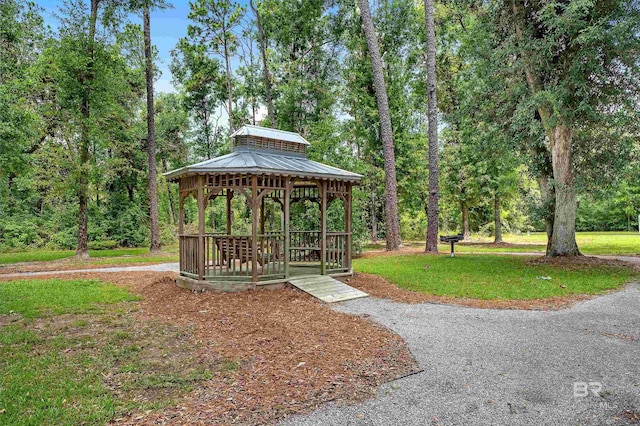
left=500, top=0, right=640, bottom=256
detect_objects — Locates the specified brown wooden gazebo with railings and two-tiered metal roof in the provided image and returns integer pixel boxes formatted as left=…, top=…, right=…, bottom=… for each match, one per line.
left=165, top=125, right=361, bottom=291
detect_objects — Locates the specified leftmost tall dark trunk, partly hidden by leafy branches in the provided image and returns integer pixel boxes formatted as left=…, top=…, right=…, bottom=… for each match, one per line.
left=76, top=0, right=99, bottom=258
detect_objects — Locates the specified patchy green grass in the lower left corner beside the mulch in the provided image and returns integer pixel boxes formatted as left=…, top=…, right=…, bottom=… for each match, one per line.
left=0, top=280, right=211, bottom=425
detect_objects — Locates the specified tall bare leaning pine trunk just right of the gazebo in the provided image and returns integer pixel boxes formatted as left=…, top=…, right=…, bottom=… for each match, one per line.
left=358, top=0, right=401, bottom=250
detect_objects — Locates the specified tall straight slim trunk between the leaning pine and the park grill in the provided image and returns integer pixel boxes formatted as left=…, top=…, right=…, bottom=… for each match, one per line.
left=424, top=0, right=439, bottom=253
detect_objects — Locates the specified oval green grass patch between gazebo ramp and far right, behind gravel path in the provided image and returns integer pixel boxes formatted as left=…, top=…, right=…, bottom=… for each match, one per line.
left=353, top=254, right=637, bottom=300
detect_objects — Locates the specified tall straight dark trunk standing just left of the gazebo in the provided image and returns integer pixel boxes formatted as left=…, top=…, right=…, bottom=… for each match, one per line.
left=143, top=2, right=162, bottom=253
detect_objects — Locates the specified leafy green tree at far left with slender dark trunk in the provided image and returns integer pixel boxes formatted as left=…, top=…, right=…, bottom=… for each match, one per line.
left=31, top=1, right=146, bottom=253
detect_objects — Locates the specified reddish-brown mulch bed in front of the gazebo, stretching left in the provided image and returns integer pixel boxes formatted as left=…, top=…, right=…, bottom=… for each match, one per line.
left=0, top=272, right=417, bottom=424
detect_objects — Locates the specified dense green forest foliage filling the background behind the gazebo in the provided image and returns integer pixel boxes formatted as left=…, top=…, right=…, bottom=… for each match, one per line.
left=0, top=0, right=640, bottom=255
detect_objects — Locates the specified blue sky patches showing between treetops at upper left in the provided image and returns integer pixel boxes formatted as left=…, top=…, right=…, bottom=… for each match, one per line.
left=36, top=0, right=254, bottom=92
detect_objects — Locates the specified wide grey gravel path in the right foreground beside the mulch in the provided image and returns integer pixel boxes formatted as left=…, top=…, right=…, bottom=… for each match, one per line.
left=284, top=285, right=640, bottom=426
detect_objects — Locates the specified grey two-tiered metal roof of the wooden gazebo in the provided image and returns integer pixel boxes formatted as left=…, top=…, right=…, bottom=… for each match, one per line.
left=165, top=125, right=362, bottom=182
